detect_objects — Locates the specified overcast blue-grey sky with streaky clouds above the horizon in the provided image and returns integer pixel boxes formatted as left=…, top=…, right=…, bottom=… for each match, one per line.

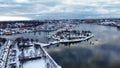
left=0, top=0, right=120, bottom=19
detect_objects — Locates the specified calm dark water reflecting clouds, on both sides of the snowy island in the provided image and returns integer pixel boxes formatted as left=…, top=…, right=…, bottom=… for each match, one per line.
left=2, top=24, right=120, bottom=68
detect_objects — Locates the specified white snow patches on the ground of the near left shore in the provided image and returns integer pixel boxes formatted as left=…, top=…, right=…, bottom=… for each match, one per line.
left=0, top=41, right=61, bottom=68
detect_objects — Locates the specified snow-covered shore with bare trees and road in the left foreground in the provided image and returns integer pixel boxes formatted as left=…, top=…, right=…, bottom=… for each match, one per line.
left=0, top=40, right=61, bottom=68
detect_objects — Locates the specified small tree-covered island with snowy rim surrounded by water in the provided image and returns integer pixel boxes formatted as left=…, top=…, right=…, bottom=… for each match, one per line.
left=52, top=30, right=94, bottom=43
